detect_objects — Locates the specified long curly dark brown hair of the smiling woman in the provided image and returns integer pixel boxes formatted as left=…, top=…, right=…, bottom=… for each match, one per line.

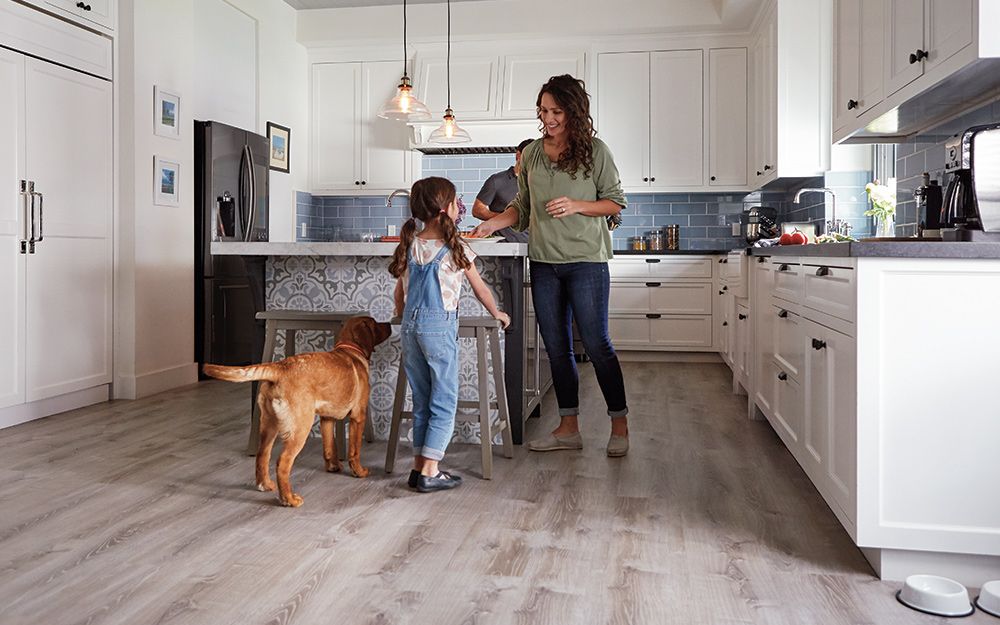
left=535, top=74, right=597, bottom=180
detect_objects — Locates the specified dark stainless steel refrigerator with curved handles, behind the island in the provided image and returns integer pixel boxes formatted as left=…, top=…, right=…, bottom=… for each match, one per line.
left=194, top=121, right=268, bottom=365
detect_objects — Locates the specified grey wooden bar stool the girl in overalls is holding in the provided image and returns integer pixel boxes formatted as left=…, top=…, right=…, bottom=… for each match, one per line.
left=385, top=317, right=514, bottom=480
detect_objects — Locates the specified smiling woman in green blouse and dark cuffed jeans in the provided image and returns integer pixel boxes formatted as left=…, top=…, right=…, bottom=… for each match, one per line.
left=476, top=75, right=628, bottom=457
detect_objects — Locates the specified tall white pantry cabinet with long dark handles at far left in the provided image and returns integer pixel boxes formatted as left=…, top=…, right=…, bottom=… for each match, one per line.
left=0, top=8, right=113, bottom=427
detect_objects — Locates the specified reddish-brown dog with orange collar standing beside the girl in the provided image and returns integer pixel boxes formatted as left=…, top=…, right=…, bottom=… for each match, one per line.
left=204, top=317, right=392, bottom=507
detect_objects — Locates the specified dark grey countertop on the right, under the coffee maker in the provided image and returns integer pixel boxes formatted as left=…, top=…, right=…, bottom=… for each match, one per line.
left=748, top=239, right=1000, bottom=259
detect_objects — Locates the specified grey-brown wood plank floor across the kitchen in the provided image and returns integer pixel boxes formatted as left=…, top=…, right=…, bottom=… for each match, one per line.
left=0, top=363, right=996, bottom=625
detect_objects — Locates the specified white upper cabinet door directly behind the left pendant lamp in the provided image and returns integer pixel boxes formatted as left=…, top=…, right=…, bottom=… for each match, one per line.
left=361, top=61, right=413, bottom=191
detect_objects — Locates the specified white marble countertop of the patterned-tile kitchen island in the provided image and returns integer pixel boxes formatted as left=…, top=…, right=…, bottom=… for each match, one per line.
left=211, top=241, right=528, bottom=257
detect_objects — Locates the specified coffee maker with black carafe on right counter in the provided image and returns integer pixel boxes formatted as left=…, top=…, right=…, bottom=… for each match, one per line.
left=941, top=124, right=1000, bottom=241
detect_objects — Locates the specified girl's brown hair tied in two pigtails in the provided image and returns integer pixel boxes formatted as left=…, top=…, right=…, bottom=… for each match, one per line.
left=389, top=176, right=472, bottom=278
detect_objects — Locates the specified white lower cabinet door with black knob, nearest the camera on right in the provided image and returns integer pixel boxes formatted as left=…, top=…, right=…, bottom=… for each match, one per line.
left=800, top=319, right=857, bottom=520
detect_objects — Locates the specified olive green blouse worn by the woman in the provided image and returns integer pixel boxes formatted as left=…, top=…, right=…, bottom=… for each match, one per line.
left=510, top=138, right=628, bottom=263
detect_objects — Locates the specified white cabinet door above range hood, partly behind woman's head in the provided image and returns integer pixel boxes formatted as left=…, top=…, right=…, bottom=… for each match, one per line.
left=500, top=54, right=584, bottom=119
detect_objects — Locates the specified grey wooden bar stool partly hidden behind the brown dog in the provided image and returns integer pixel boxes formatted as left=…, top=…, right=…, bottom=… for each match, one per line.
left=247, top=310, right=375, bottom=460
